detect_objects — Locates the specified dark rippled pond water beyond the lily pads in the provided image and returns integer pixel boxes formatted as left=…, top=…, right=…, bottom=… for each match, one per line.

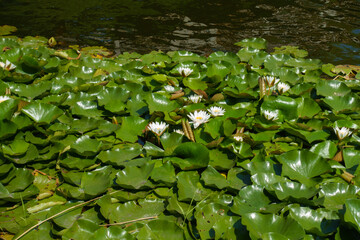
left=0, top=0, right=360, bottom=65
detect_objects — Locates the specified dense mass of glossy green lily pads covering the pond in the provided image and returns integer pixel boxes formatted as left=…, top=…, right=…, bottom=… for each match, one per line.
left=0, top=37, right=360, bottom=239
